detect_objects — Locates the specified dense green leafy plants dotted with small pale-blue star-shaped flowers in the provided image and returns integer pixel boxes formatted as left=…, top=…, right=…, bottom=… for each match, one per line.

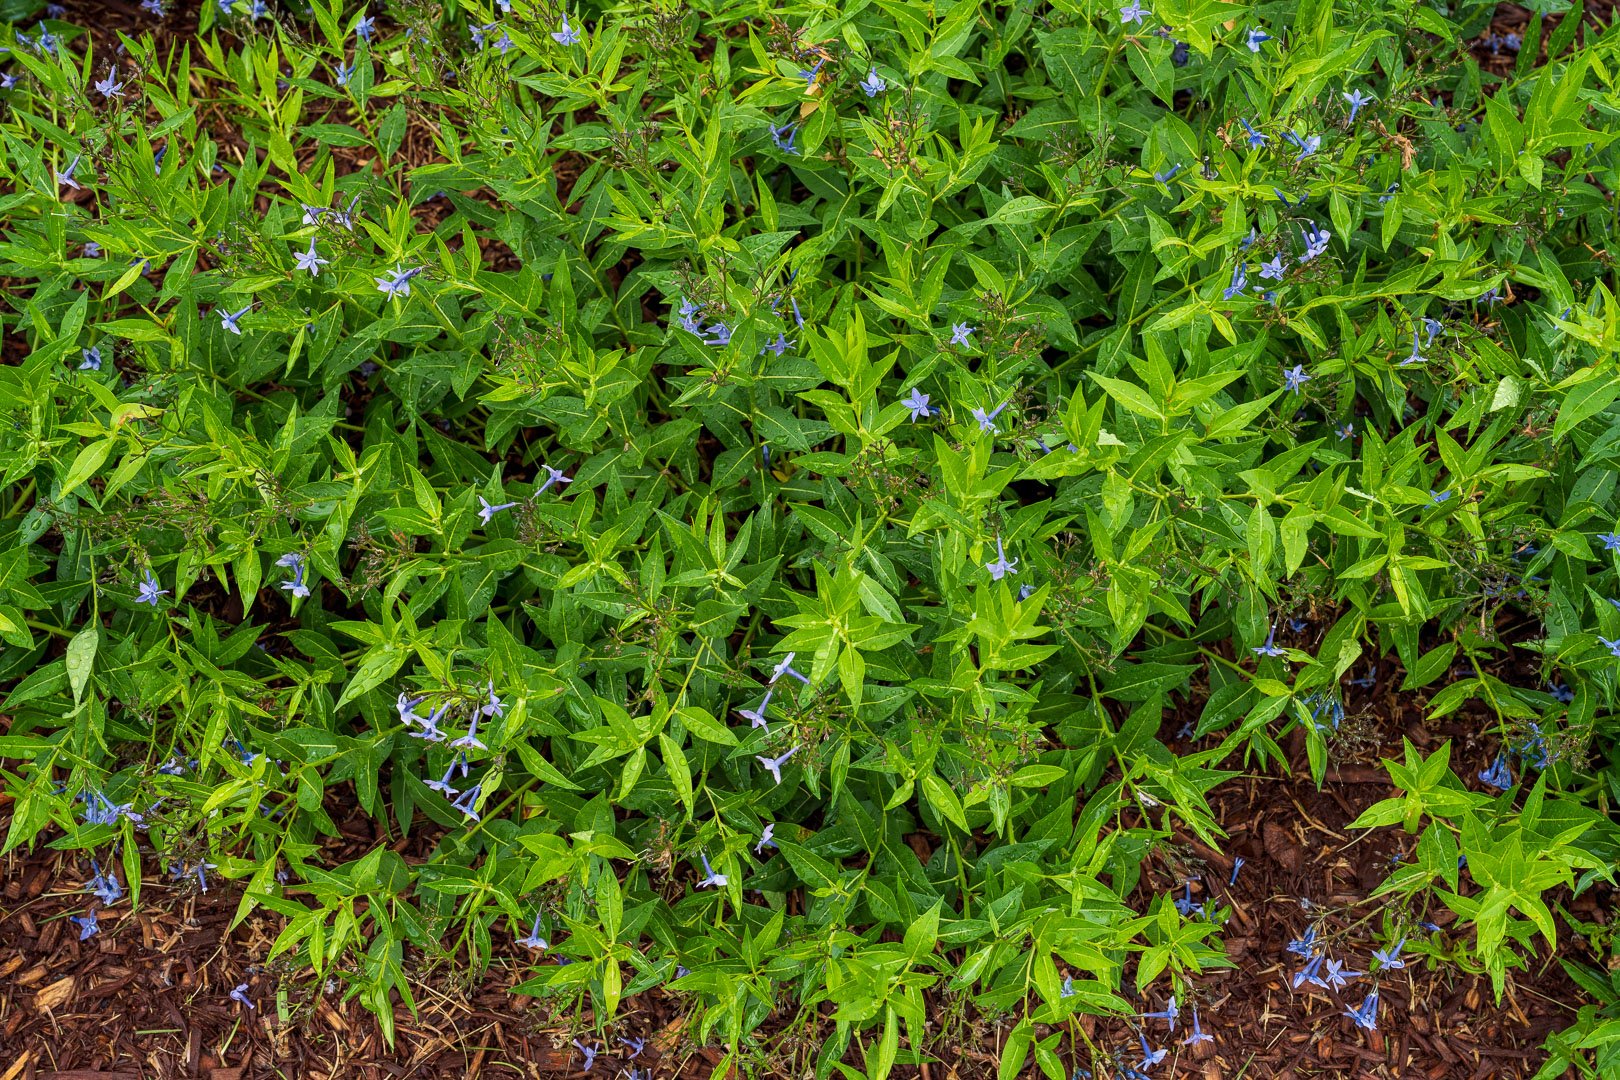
left=0, top=0, right=1620, bottom=1078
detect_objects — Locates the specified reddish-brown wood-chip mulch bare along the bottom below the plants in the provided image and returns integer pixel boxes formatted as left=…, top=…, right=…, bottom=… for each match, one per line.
left=0, top=683, right=1594, bottom=1080
